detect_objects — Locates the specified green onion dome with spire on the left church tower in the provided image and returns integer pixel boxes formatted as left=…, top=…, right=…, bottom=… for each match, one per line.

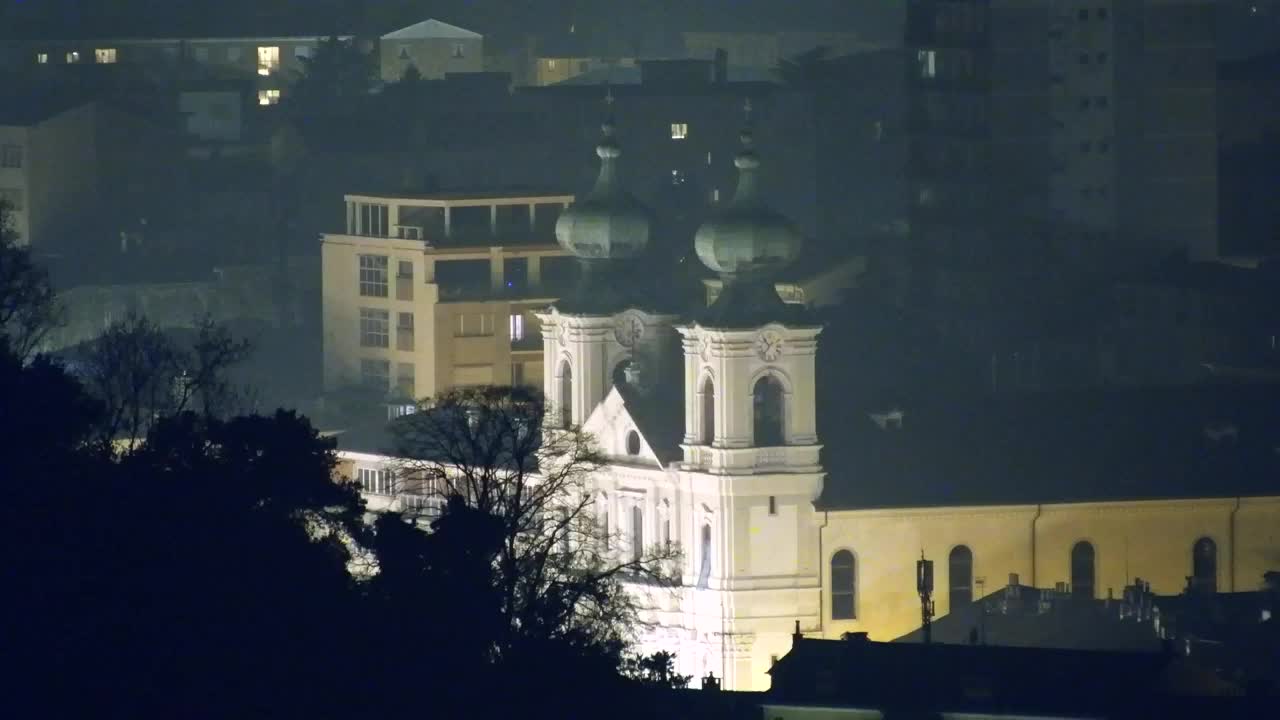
left=556, top=110, right=652, bottom=260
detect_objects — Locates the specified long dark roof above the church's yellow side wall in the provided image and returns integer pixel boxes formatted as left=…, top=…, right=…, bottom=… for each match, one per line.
left=818, top=377, right=1280, bottom=510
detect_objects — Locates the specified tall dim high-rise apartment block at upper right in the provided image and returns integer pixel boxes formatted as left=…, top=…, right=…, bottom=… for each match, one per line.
left=906, top=0, right=1217, bottom=288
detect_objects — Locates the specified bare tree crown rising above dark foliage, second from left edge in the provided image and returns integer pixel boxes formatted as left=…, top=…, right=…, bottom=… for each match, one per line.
left=79, top=315, right=250, bottom=452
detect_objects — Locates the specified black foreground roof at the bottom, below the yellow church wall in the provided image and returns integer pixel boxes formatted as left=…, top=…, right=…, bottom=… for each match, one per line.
left=767, top=635, right=1171, bottom=716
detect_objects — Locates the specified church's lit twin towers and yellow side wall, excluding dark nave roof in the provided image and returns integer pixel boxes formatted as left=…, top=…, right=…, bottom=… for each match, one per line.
left=335, top=99, right=1280, bottom=689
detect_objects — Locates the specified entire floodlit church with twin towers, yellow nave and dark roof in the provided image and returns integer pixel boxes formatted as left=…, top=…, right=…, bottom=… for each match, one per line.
left=340, top=101, right=1280, bottom=691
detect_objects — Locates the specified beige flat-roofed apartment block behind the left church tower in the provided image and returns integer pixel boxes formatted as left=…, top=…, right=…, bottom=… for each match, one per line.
left=321, top=191, right=573, bottom=401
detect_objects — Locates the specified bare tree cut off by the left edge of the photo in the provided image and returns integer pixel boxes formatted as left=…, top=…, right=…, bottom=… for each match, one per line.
left=0, top=200, right=63, bottom=360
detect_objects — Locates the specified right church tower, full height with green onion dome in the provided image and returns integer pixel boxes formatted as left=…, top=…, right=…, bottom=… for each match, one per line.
left=677, top=105, right=823, bottom=688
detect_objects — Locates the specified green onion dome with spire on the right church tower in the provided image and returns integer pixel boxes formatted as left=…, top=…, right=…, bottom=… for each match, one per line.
left=694, top=117, right=803, bottom=280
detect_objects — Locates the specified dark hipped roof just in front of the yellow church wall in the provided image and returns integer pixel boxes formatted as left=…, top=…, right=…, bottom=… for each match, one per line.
left=893, top=585, right=1162, bottom=652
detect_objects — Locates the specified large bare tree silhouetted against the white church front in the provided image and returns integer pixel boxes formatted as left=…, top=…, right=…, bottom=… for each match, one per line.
left=392, top=387, right=678, bottom=657
